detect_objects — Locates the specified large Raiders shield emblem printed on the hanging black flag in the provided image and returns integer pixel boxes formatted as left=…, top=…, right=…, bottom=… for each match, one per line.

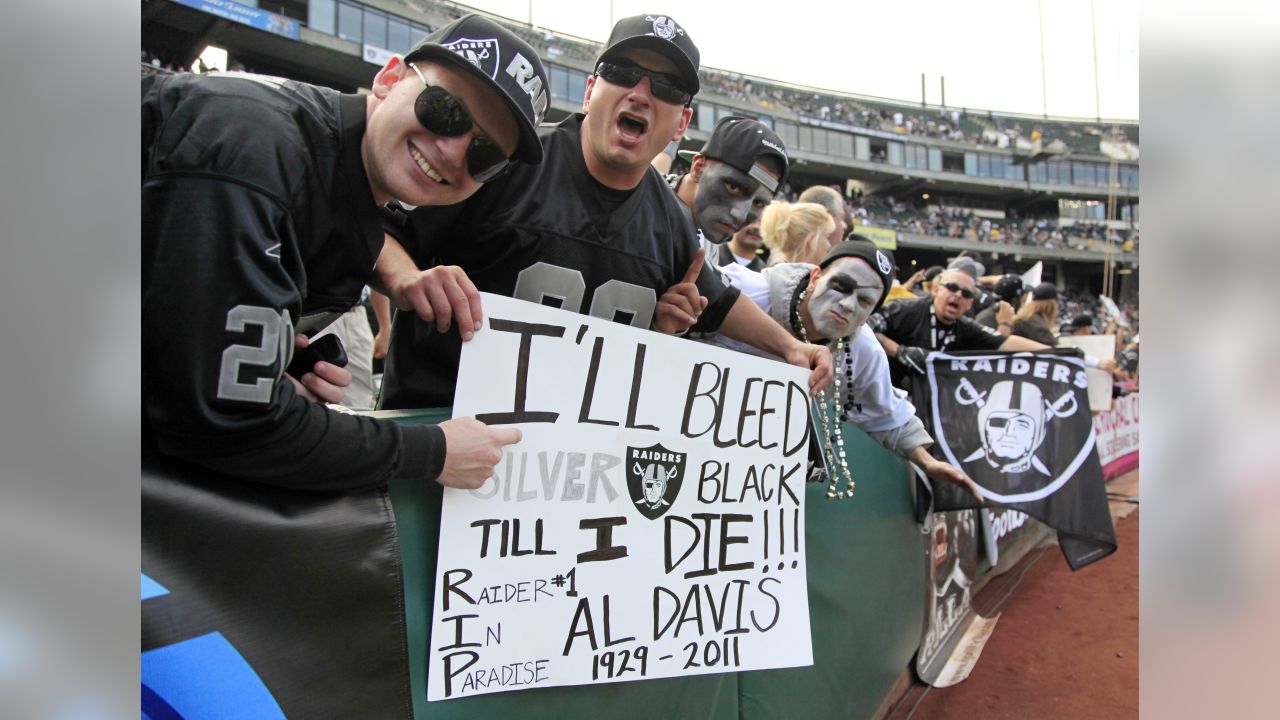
left=929, top=354, right=1094, bottom=502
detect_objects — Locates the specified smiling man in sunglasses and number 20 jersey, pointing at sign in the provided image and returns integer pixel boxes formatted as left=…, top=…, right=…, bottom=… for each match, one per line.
left=142, top=15, right=547, bottom=489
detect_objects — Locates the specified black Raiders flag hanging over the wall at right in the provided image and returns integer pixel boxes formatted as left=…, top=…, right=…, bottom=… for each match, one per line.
left=913, top=350, right=1116, bottom=570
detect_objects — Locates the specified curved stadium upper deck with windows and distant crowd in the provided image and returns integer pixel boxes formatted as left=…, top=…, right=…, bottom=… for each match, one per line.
left=142, top=0, right=1139, bottom=293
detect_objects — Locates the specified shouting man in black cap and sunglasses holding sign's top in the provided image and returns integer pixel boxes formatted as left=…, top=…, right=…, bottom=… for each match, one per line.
left=379, top=14, right=831, bottom=409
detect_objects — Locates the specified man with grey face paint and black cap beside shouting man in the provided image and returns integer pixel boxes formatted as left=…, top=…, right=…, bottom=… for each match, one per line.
left=667, top=115, right=787, bottom=252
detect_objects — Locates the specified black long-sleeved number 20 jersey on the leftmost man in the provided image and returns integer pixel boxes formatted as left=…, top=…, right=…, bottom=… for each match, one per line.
left=142, top=73, right=444, bottom=489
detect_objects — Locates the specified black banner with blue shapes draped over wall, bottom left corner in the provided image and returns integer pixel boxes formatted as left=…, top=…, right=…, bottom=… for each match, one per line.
left=141, top=452, right=412, bottom=719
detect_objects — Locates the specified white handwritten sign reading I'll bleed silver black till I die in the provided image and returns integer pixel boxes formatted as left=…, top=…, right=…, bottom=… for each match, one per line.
left=428, top=293, right=813, bottom=701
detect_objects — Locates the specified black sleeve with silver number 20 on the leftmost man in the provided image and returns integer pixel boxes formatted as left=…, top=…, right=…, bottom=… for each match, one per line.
left=142, top=176, right=444, bottom=489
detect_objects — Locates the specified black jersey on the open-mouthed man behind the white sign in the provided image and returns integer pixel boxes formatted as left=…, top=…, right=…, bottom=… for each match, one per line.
left=380, top=110, right=737, bottom=407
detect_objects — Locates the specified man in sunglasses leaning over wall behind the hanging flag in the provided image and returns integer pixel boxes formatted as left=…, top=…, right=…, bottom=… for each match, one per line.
left=868, top=268, right=1048, bottom=388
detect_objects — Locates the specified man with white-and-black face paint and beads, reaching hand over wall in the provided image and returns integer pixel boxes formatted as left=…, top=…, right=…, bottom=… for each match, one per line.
left=709, top=234, right=982, bottom=500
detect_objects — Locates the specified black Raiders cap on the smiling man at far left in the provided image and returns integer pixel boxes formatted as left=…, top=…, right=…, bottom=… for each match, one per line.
left=404, top=14, right=549, bottom=165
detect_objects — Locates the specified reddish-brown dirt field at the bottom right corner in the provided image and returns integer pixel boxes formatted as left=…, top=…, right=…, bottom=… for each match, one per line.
left=888, top=473, right=1138, bottom=720
